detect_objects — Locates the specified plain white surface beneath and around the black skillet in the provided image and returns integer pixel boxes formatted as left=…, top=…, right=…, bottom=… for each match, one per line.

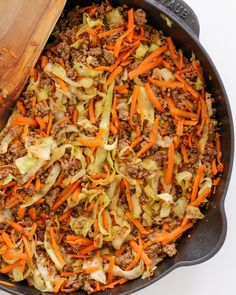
left=0, top=0, right=236, bottom=295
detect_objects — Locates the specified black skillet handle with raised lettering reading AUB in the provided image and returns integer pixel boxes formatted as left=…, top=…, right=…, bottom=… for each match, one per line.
left=155, top=0, right=200, bottom=38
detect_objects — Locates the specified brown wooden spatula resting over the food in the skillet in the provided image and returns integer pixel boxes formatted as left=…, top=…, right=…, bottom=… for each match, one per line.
left=0, top=0, right=66, bottom=129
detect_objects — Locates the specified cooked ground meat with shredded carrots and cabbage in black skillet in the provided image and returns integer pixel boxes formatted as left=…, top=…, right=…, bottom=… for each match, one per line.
left=0, top=2, right=223, bottom=293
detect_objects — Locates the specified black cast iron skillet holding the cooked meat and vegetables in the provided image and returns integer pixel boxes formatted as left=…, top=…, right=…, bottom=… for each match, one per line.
left=0, top=0, right=234, bottom=295
